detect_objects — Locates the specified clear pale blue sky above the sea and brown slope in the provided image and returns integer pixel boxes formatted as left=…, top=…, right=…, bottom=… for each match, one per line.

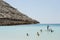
left=5, top=0, right=60, bottom=24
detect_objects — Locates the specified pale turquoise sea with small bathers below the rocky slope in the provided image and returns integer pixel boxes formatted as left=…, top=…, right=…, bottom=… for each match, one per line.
left=0, top=24, right=60, bottom=40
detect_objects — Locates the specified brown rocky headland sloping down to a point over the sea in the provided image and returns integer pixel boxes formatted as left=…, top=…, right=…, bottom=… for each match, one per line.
left=0, top=0, right=39, bottom=25
